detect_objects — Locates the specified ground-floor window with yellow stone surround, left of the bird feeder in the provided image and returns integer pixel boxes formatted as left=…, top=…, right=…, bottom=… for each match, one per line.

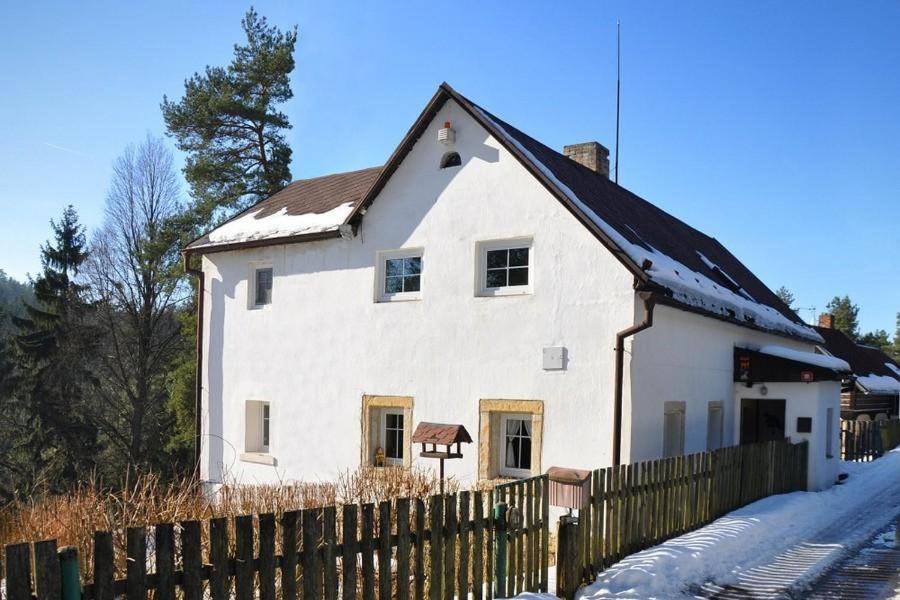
left=360, top=395, right=413, bottom=467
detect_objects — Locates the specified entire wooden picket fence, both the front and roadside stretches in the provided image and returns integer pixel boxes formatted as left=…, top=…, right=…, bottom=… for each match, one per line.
left=3, top=441, right=807, bottom=600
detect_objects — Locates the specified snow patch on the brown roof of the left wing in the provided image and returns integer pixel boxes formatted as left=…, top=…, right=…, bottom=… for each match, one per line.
left=191, top=202, right=354, bottom=245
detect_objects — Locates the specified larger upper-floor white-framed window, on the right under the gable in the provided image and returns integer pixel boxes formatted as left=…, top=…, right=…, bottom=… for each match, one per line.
left=478, top=238, right=533, bottom=296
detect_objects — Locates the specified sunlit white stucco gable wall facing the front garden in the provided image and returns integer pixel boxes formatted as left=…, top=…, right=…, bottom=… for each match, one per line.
left=202, top=102, right=636, bottom=483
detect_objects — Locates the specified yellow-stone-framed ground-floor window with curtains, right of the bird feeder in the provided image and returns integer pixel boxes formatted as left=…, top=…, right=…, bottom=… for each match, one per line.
left=478, top=400, right=544, bottom=479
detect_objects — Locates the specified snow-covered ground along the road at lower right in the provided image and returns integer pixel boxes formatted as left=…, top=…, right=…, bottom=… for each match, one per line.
left=524, top=450, right=900, bottom=600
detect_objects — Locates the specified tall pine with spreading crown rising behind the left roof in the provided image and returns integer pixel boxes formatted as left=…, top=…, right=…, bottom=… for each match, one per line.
left=162, top=8, right=297, bottom=227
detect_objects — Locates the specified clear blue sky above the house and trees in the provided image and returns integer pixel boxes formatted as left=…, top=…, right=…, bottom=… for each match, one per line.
left=0, top=0, right=900, bottom=331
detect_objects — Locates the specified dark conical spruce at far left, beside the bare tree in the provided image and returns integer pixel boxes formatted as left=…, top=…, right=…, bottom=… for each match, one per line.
left=13, top=206, right=98, bottom=485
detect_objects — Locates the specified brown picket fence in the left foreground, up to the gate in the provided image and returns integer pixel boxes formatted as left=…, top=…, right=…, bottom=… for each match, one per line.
left=4, top=491, right=506, bottom=600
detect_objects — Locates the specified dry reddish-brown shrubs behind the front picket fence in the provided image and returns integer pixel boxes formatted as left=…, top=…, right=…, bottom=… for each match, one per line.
left=0, top=467, right=459, bottom=577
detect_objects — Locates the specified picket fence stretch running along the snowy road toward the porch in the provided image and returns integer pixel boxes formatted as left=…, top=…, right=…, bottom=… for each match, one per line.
left=557, top=440, right=808, bottom=596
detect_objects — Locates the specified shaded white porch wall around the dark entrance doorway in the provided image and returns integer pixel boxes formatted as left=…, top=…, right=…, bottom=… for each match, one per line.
left=732, top=381, right=841, bottom=491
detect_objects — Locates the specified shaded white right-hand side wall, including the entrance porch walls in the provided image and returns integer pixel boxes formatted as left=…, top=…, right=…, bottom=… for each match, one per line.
left=623, top=306, right=840, bottom=489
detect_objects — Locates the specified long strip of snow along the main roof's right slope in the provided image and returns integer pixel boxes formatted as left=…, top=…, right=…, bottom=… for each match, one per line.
left=473, top=104, right=824, bottom=344
